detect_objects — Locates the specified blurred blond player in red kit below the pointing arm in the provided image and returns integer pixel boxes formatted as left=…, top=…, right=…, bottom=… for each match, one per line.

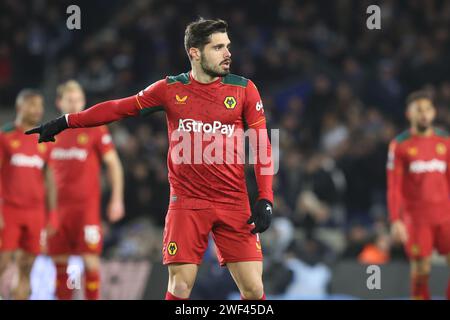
left=48, top=80, right=124, bottom=300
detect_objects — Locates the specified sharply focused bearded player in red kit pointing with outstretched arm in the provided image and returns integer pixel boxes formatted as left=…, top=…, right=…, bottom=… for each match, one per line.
left=28, top=19, right=273, bottom=299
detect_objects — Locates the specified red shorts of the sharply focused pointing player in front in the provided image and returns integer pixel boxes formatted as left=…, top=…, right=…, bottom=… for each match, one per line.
left=163, top=208, right=263, bottom=266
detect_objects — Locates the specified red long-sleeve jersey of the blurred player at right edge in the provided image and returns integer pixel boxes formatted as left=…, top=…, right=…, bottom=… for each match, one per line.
left=387, top=129, right=450, bottom=223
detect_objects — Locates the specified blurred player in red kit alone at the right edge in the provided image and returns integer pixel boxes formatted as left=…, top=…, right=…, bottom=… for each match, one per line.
left=387, top=91, right=450, bottom=299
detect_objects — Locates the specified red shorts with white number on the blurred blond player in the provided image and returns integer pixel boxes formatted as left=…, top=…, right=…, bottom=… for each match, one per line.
left=47, top=201, right=103, bottom=255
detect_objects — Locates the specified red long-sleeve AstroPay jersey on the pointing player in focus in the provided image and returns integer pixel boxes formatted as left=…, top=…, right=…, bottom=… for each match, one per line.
left=67, top=73, right=273, bottom=208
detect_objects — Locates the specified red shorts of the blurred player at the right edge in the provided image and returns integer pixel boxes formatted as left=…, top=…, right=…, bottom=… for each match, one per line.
left=405, top=215, right=450, bottom=259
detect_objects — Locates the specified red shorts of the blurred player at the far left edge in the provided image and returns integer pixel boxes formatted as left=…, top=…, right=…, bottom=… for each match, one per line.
left=0, top=204, right=46, bottom=255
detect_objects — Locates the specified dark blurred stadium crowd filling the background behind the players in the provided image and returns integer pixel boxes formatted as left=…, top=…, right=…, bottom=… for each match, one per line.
left=0, top=0, right=450, bottom=297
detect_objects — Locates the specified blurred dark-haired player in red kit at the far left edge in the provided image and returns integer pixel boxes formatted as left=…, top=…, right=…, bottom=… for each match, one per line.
left=0, top=89, right=56, bottom=299
